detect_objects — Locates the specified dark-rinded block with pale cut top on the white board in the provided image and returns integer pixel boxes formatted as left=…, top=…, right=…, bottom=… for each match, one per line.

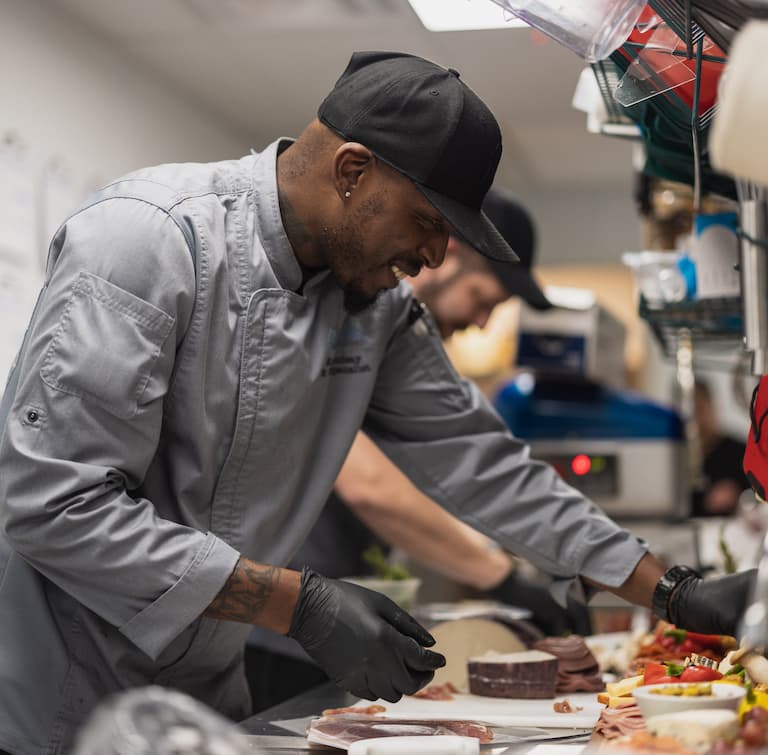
left=467, top=650, right=557, bottom=699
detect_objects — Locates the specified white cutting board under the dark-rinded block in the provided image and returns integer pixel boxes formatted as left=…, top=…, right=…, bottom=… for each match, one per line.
left=357, top=692, right=605, bottom=729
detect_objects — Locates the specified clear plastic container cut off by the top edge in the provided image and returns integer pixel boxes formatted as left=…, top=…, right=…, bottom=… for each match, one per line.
left=493, top=0, right=645, bottom=63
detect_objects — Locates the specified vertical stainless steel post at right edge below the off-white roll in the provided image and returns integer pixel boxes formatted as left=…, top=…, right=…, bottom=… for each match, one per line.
left=740, top=199, right=768, bottom=375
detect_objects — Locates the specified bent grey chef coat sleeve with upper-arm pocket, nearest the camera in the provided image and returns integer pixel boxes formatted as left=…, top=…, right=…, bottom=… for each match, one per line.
left=0, top=198, right=238, bottom=658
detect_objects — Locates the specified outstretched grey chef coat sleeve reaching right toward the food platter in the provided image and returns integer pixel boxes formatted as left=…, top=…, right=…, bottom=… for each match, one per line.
left=365, top=304, right=647, bottom=602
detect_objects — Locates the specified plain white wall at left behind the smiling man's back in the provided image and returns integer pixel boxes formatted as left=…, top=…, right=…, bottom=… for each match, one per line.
left=0, top=0, right=250, bottom=386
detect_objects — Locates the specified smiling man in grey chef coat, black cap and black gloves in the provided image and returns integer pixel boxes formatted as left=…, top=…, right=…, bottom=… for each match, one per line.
left=0, top=52, right=750, bottom=755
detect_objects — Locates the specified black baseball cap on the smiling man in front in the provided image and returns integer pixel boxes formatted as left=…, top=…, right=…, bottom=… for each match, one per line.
left=317, top=52, right=517, bottom=262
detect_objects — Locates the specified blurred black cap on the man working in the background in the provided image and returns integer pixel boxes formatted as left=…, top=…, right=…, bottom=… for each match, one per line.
left=483, top=187, right=553, bottom=309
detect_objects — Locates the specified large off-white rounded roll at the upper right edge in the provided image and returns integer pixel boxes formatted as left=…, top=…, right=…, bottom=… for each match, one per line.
left=709, top=21, right=768, bottom=186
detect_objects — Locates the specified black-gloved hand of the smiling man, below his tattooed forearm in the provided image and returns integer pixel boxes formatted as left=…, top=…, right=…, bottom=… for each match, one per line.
left=288, top=567, right=445, bottom=703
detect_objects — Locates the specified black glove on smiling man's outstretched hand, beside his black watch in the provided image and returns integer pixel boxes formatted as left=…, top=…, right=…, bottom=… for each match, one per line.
left=662, top=569, right=757, bottom=636
